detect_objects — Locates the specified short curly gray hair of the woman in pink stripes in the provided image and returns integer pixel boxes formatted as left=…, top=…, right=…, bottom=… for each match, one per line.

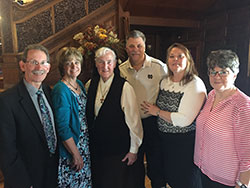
left=207, top=50, right=240, bottom=74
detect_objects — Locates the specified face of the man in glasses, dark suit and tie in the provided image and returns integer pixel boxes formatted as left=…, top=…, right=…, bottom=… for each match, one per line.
left=19, top=49, right=50, bottom=88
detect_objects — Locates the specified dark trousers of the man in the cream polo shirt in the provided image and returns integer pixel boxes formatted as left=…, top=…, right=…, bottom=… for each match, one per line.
left=137, top=116, right=166, bottom=188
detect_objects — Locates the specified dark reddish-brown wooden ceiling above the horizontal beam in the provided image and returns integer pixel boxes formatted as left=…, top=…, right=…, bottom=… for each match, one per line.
left=121, top=0, right=217, bottom=19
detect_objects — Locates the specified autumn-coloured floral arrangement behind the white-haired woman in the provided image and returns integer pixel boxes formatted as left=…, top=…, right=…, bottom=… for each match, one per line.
left=73, top=25, right=125, bottom=60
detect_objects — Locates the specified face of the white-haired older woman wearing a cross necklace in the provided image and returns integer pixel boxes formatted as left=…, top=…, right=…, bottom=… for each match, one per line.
left=95, top=52, right=116, bottom=82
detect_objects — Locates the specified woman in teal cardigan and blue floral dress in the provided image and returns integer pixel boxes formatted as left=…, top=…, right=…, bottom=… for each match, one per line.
left=52, top=47, right=92, bottom=188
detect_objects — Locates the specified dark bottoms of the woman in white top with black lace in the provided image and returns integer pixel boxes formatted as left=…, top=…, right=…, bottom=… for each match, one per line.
left=160, top=131, right=201, bottom=188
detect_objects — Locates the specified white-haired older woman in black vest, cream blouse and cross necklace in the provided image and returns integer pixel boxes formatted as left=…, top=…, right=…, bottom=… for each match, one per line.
left=87, top=47, right=143, bottom=188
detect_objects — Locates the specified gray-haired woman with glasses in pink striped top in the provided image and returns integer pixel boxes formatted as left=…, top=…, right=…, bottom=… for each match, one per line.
left=194, top=50, right=250, bottom=188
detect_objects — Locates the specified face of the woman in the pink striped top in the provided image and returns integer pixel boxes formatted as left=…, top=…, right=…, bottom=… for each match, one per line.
left=209, top=66, right=236, bottom=92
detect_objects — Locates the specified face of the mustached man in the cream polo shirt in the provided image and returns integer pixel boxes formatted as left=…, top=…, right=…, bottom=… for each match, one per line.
left=126, top=37, right=145, bottom=64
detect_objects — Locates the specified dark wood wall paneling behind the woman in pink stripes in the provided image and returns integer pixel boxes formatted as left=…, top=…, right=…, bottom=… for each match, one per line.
left=202, top=6, right=250, bottom=95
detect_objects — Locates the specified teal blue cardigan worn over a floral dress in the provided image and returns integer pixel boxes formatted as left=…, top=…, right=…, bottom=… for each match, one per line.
left=52, top=80, right=86, bottom=159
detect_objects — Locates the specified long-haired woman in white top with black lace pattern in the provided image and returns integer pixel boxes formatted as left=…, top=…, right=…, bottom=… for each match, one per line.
left=141, top=43, right=206, bottom=188
